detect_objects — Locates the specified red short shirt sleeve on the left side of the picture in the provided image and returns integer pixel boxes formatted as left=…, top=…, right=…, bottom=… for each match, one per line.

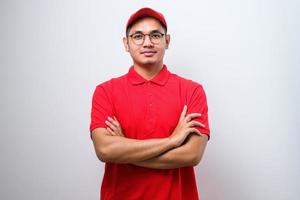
left=90, top=85, right=113, bottom=138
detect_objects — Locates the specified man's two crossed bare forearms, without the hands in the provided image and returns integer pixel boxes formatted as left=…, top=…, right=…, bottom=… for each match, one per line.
left=93, top=128, right=208, bottom=169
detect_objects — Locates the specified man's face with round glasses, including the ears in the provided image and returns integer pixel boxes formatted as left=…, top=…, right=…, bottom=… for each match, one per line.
left=123, top=17, right=170, bottom=66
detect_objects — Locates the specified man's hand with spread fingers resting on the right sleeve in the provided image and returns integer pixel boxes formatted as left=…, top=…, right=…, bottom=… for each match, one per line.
left=170, top=105, right=205, bottom=147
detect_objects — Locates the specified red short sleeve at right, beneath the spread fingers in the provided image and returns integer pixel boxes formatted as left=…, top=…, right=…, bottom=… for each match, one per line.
left=187, top=85, right=210, bottom=139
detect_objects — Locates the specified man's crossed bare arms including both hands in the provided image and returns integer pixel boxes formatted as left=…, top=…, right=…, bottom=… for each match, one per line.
left=92, top=107, right=208, bottom=169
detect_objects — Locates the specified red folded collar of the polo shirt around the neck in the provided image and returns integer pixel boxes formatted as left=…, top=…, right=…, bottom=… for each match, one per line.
left=127, top=65, right=170, bottom=86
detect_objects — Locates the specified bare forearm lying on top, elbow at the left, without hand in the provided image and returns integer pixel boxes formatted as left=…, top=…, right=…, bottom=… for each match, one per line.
left=94, top=128, right=174, bottom=163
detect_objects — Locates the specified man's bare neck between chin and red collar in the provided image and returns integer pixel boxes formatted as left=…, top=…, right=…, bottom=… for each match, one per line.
left=133, top=63, right=163, bottom=80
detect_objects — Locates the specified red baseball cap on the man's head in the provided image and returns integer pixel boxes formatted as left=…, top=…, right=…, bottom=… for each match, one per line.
left=126, top=8, right=168, bottom=31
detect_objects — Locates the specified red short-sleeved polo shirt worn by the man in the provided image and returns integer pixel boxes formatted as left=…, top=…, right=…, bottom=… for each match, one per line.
left=90, top=65, right=210, bottom=200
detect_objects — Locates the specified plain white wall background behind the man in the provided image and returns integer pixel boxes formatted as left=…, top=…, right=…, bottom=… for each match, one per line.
left=0, top=0, right=300, bottom=200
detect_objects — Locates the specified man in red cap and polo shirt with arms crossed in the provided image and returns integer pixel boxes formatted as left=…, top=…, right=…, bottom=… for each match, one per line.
left=90, top=8, right=210, bottom=200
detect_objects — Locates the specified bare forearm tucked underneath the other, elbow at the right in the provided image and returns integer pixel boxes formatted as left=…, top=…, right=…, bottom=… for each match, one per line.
left=133, top=135, right=207, bottom=169
